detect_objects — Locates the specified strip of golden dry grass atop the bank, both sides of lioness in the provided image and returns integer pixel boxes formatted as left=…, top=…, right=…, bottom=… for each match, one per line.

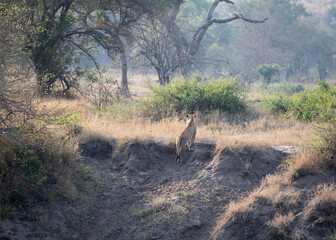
left=80, top=110, right=310, bottom=148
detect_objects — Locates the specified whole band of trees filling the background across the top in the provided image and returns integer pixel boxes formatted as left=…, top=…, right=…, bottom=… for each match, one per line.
left=0, top=0, right=336, bottom=103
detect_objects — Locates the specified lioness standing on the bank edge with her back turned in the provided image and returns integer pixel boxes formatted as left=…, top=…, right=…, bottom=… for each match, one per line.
left=176, top=114, right=196, bottom=162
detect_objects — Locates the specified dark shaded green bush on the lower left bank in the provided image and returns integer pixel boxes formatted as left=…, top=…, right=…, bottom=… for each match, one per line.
left=0, top=130, right=71, bottom=218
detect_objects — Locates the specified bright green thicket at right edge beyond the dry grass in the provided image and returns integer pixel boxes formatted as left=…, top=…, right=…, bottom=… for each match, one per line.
left=263, top=81, right=336, bottom=122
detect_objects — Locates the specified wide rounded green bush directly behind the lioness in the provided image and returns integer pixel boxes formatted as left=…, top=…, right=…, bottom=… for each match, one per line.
left=143, top=77, right=246, bottom=118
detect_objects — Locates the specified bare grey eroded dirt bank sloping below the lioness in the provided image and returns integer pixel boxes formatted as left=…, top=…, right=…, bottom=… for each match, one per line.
left=0, top=140, right=296, bottom=240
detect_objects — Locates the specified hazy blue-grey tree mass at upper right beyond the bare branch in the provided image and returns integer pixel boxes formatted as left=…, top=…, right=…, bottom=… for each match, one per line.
left=223, top=0, right=335, bottom=82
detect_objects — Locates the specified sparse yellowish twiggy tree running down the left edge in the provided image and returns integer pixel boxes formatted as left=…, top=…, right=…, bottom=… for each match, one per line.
left=0, top=1, right=36, bottom=129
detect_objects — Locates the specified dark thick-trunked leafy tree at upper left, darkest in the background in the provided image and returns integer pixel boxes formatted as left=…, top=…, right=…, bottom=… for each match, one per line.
left=18, top=0, right=80, bottom=94
